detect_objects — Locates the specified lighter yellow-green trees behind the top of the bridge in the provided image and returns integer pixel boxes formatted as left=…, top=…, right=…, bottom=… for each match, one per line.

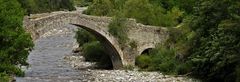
left=85, top=0, right=183, bottom=27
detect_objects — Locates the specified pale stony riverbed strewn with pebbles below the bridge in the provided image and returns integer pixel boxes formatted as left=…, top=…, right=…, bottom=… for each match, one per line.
left=64, top=55, right=197, bottom=82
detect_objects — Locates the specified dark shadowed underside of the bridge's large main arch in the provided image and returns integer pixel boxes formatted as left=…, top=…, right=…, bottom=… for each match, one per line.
left=71, top=24, right=123, bottom=69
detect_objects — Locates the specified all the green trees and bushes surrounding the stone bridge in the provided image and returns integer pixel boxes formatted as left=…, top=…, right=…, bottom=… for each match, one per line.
left=0, top=0, right=240, bottom=82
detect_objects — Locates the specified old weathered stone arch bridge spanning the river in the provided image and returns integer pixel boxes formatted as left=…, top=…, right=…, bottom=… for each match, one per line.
left=24, top=12, right=168, bottom=69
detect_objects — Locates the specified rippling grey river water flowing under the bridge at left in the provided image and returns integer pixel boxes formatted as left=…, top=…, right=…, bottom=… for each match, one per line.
left=16, top=25, right=92, bottom=82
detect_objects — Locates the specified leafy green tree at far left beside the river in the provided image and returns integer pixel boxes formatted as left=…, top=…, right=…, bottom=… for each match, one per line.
left=0, top=0, right=33, bottom=80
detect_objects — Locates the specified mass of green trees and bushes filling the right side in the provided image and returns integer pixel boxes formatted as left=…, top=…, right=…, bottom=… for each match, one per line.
left=79, top=0, right=240, bottom=82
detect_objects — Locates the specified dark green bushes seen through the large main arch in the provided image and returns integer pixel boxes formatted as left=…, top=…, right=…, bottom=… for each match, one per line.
left=75, top=29, right=113, bottom=69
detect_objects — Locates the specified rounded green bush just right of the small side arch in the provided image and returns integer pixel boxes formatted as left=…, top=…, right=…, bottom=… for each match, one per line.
left=149, top=46, right=178, bottom=74
